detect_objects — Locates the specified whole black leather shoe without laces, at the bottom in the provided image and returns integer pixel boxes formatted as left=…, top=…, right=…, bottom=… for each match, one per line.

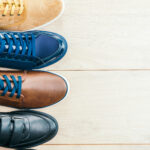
left=0, top=110, right=58, bottom=149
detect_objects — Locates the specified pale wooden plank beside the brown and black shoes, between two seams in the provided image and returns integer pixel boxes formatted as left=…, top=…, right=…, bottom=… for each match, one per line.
left=0, top=71, right=150, bottom=144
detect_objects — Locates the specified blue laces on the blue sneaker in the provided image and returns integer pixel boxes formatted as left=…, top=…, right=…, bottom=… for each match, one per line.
left=0, top=33, right=35, bottom=57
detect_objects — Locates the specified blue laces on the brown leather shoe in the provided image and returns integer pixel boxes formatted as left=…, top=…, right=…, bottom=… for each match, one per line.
left=0, top=75, right=22, bottom=98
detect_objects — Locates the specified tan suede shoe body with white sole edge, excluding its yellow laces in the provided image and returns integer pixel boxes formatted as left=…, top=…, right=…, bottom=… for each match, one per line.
left=0, top=0, right=64, bottom=31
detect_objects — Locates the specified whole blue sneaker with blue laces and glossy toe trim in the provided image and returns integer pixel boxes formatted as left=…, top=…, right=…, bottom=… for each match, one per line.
left=0, top=31, right=67, bottom=70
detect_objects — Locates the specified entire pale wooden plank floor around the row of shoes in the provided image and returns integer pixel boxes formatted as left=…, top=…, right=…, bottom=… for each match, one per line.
left=0, top=0, right=150, bottom=150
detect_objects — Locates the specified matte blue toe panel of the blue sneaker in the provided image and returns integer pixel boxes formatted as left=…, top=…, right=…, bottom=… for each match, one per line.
left=35, top=34, right=59, bottom=58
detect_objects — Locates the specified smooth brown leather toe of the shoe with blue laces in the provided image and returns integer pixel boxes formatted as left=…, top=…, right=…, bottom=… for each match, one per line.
left=22, top=72, right=68, bottom=108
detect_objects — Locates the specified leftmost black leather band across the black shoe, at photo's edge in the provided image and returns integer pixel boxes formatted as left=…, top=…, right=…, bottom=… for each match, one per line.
left=0, top=116, right=11, bottom=145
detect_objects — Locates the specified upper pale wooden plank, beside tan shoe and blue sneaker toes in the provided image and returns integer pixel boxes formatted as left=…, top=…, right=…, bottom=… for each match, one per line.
left=38, top=0, right=150, bottom=70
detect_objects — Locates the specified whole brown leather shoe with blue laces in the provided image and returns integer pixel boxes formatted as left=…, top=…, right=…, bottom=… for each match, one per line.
left=0, top=71, right=68, bottom=108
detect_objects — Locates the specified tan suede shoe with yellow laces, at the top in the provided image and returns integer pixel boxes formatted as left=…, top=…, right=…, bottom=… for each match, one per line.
left=0, top=0, right=64, bottom=31
